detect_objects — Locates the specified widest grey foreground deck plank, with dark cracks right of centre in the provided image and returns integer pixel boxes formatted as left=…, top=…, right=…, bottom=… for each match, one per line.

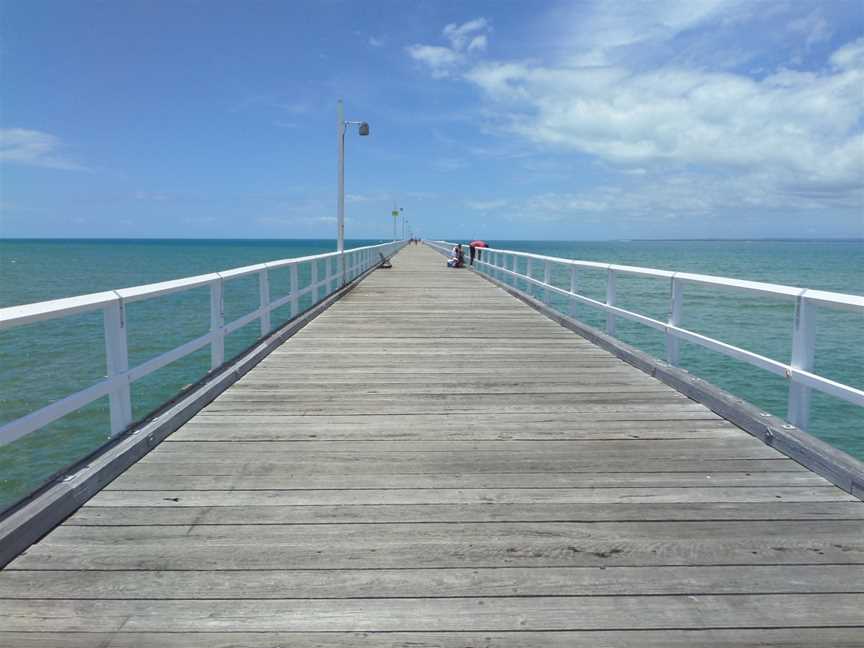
left=11, top=520, right=864, bottom=570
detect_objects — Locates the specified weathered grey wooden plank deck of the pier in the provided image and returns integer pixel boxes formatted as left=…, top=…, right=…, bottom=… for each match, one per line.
left=0, top=248, right=864, bottom=648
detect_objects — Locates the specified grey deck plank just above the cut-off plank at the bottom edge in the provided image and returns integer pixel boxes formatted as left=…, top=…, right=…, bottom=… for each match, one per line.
left=0, top=594, right=864, bottom=632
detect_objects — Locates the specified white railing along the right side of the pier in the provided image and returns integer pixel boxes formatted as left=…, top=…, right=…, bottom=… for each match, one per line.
left=426, top=241, right=864, bottom=429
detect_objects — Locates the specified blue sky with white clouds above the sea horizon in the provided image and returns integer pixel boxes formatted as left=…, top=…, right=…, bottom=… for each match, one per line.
left=0, top=0, right=864, bottom=239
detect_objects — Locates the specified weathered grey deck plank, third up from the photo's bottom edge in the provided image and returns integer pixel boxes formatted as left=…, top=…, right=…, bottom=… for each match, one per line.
left=0, top=565, right=864, bottom=600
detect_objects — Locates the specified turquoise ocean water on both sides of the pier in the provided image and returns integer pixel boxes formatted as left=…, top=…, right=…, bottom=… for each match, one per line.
left=0, top=240, right=864, bottom=509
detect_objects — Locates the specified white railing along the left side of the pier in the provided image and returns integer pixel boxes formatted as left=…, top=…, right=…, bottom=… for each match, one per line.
left=0, top=241, right=405, bottom=445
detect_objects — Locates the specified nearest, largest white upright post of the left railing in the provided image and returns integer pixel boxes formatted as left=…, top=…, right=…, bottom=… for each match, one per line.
left=102, top=296, right=132, bottom=436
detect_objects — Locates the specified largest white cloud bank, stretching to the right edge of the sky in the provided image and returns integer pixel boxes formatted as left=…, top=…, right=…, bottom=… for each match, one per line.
left=465, top=55, right=864, bottom=196
